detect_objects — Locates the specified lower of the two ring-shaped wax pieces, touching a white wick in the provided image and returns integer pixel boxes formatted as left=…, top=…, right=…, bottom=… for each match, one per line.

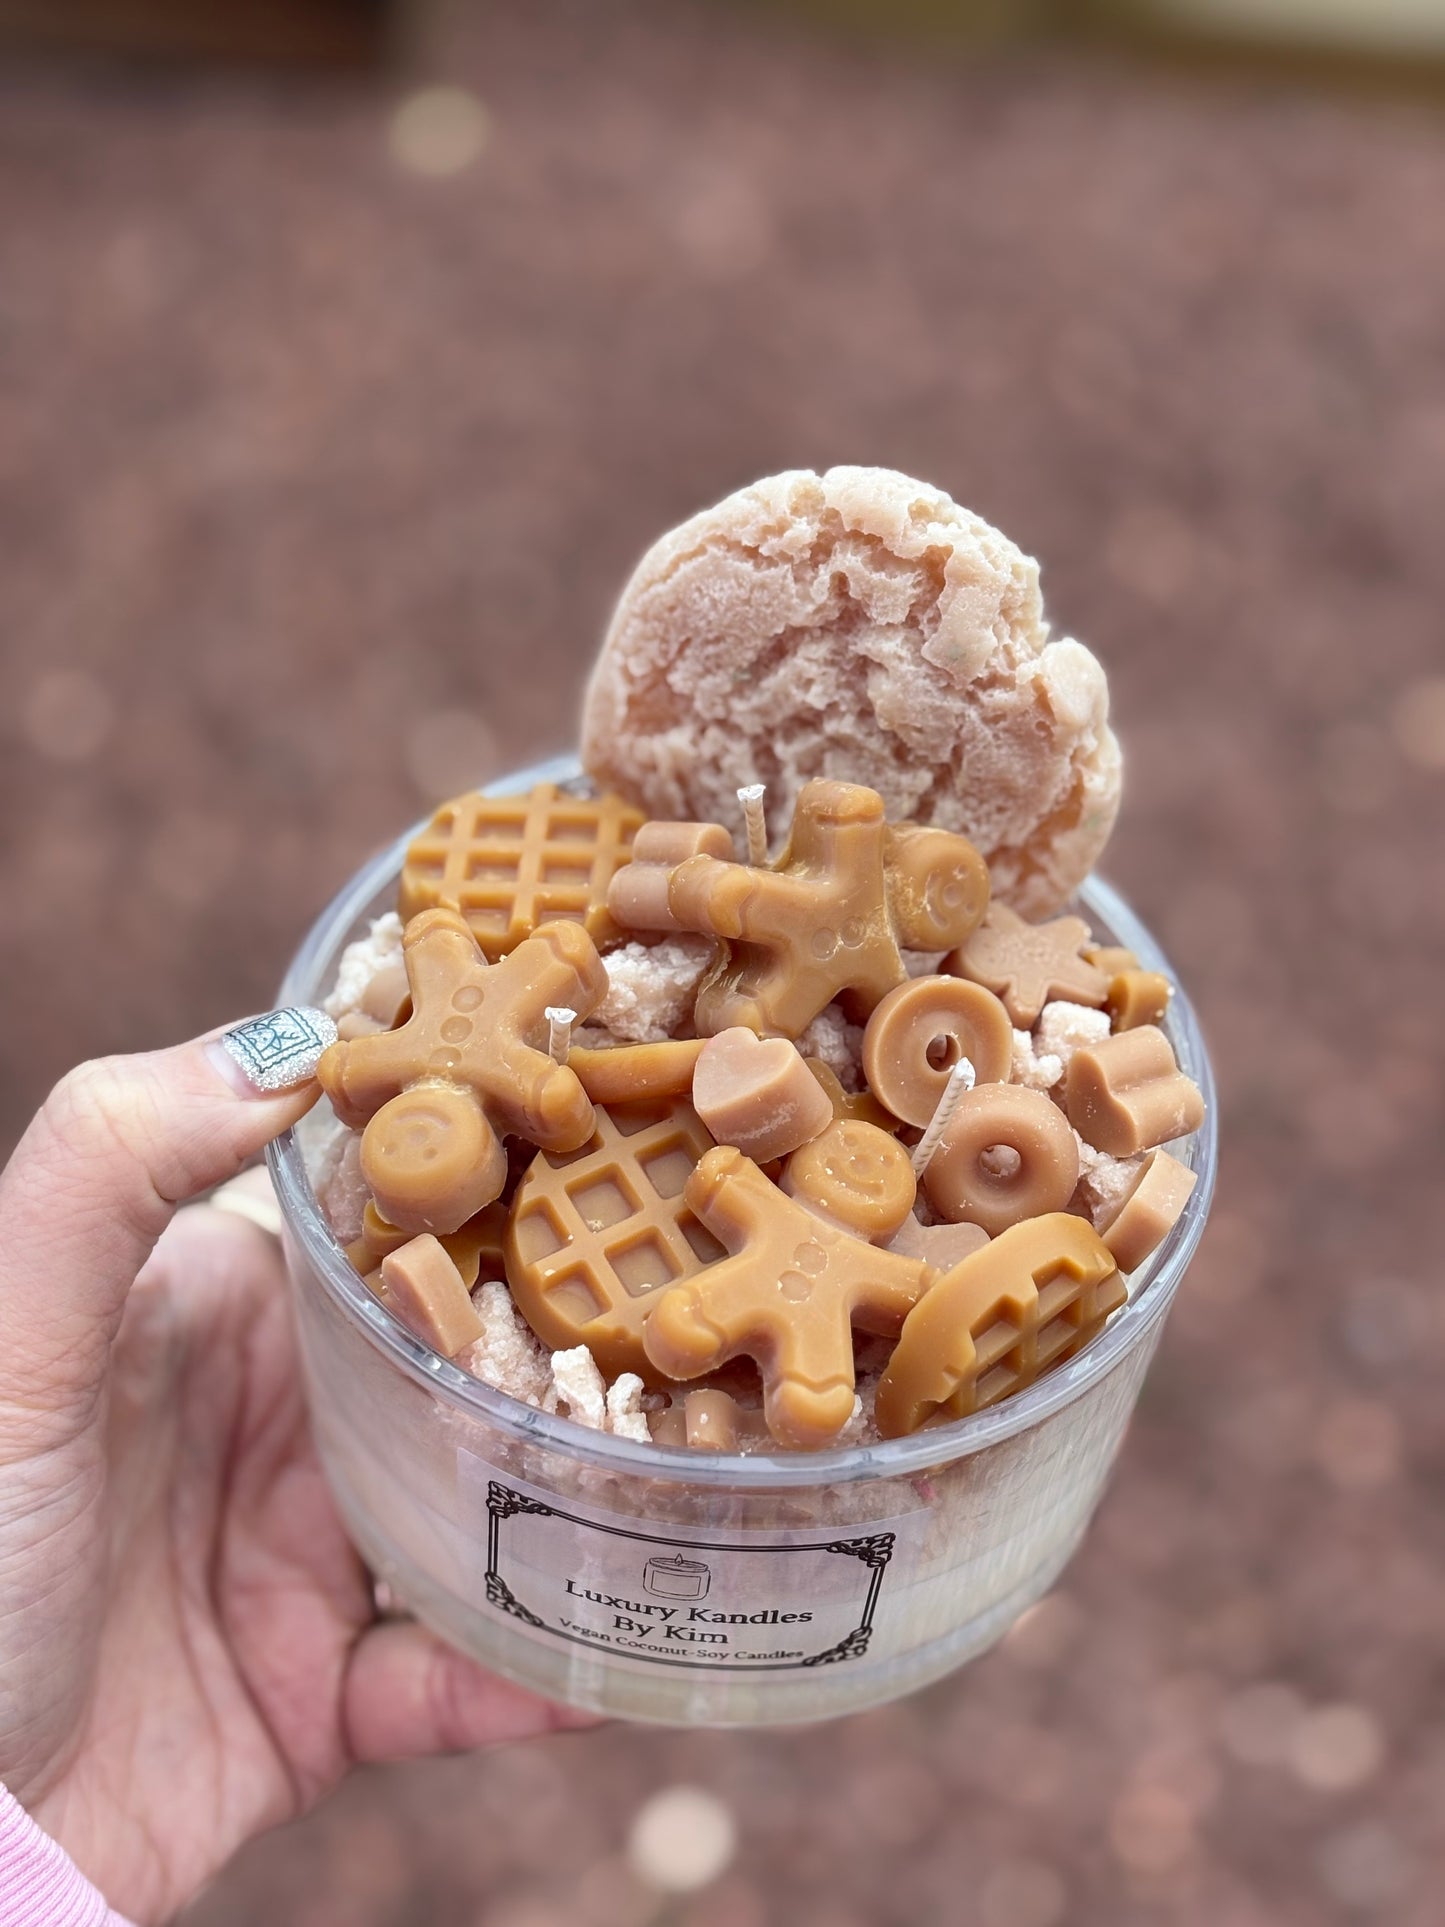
left=923, top=1085, right=1079, bottom=1237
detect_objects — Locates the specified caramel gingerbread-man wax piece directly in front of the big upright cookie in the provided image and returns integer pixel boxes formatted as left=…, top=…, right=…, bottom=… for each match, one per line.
left=669, top=780, right=988, bottom=1037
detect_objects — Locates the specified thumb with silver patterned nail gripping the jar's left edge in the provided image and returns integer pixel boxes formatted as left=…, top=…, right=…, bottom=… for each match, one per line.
left=0, top=1010, right=335, bottom=1407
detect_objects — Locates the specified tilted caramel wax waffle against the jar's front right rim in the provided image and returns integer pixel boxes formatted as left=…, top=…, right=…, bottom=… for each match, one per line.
left=875, top=1212, right=1127, bottom=1438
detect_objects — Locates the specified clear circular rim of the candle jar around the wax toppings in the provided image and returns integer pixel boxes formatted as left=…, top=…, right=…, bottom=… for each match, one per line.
left=266, top=755, right=1220, bottom=1491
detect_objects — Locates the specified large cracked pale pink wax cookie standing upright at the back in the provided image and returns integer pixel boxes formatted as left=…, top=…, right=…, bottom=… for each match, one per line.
left=582, top=468, right=1119, bottom=917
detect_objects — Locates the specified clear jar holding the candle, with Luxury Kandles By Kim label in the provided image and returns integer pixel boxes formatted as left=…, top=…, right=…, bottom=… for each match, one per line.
left=270, top=759, right=1216, bottom=1727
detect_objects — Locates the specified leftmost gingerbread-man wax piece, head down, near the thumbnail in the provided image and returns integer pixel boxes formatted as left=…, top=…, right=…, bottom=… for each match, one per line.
left=316, top=910, right=607, bottom=1233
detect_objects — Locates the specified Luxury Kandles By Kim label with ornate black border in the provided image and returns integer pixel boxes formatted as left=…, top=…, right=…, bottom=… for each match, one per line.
left=462, top=1459, right=917, bottom=1673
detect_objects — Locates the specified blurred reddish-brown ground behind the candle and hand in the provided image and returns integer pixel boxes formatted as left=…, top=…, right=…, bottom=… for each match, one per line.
left=0, top=0, right=1445, bottom=1927
